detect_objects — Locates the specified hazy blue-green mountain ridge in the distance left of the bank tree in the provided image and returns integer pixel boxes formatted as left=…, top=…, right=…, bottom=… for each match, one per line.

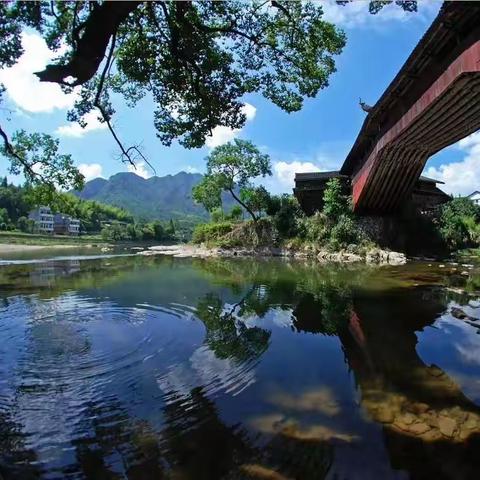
left=73, top=172, right=211, bottom=220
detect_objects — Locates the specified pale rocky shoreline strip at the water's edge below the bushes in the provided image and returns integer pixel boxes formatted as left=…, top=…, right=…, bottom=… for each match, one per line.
left=138, top=244, right=407, bottom=265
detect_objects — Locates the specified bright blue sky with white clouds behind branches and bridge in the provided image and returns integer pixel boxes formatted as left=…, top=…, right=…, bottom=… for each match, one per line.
left=0, top=2, right=480, bottom=194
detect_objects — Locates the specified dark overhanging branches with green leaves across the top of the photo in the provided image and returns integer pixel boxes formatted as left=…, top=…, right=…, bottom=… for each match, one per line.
left=0, top=0, right=416, bottom=185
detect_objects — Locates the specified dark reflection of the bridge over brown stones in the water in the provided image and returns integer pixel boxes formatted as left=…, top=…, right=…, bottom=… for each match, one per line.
left=340, top=291, right=480, bottom=479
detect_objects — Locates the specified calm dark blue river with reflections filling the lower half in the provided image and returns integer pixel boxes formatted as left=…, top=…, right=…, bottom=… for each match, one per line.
left=0, top=256, right=480, bottom=480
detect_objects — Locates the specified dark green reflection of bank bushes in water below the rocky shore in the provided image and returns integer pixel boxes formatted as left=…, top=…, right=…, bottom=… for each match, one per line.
left=196, top=259, right=364, bottom=335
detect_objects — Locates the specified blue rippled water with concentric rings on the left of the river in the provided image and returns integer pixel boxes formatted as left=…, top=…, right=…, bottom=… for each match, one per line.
left=0, top=292, right=256, bottom=478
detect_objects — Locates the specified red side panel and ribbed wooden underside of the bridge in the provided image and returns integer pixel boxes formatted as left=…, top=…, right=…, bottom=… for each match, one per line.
left=352, top=41, right=480, bottom=213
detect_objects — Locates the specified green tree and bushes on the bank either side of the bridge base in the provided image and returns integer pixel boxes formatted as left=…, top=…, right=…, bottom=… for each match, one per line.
left=192, top=140, right=480, bottom=259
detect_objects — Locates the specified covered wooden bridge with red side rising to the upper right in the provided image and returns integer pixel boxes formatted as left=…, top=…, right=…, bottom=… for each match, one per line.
left=295, top=1, right=480, bottom=213
